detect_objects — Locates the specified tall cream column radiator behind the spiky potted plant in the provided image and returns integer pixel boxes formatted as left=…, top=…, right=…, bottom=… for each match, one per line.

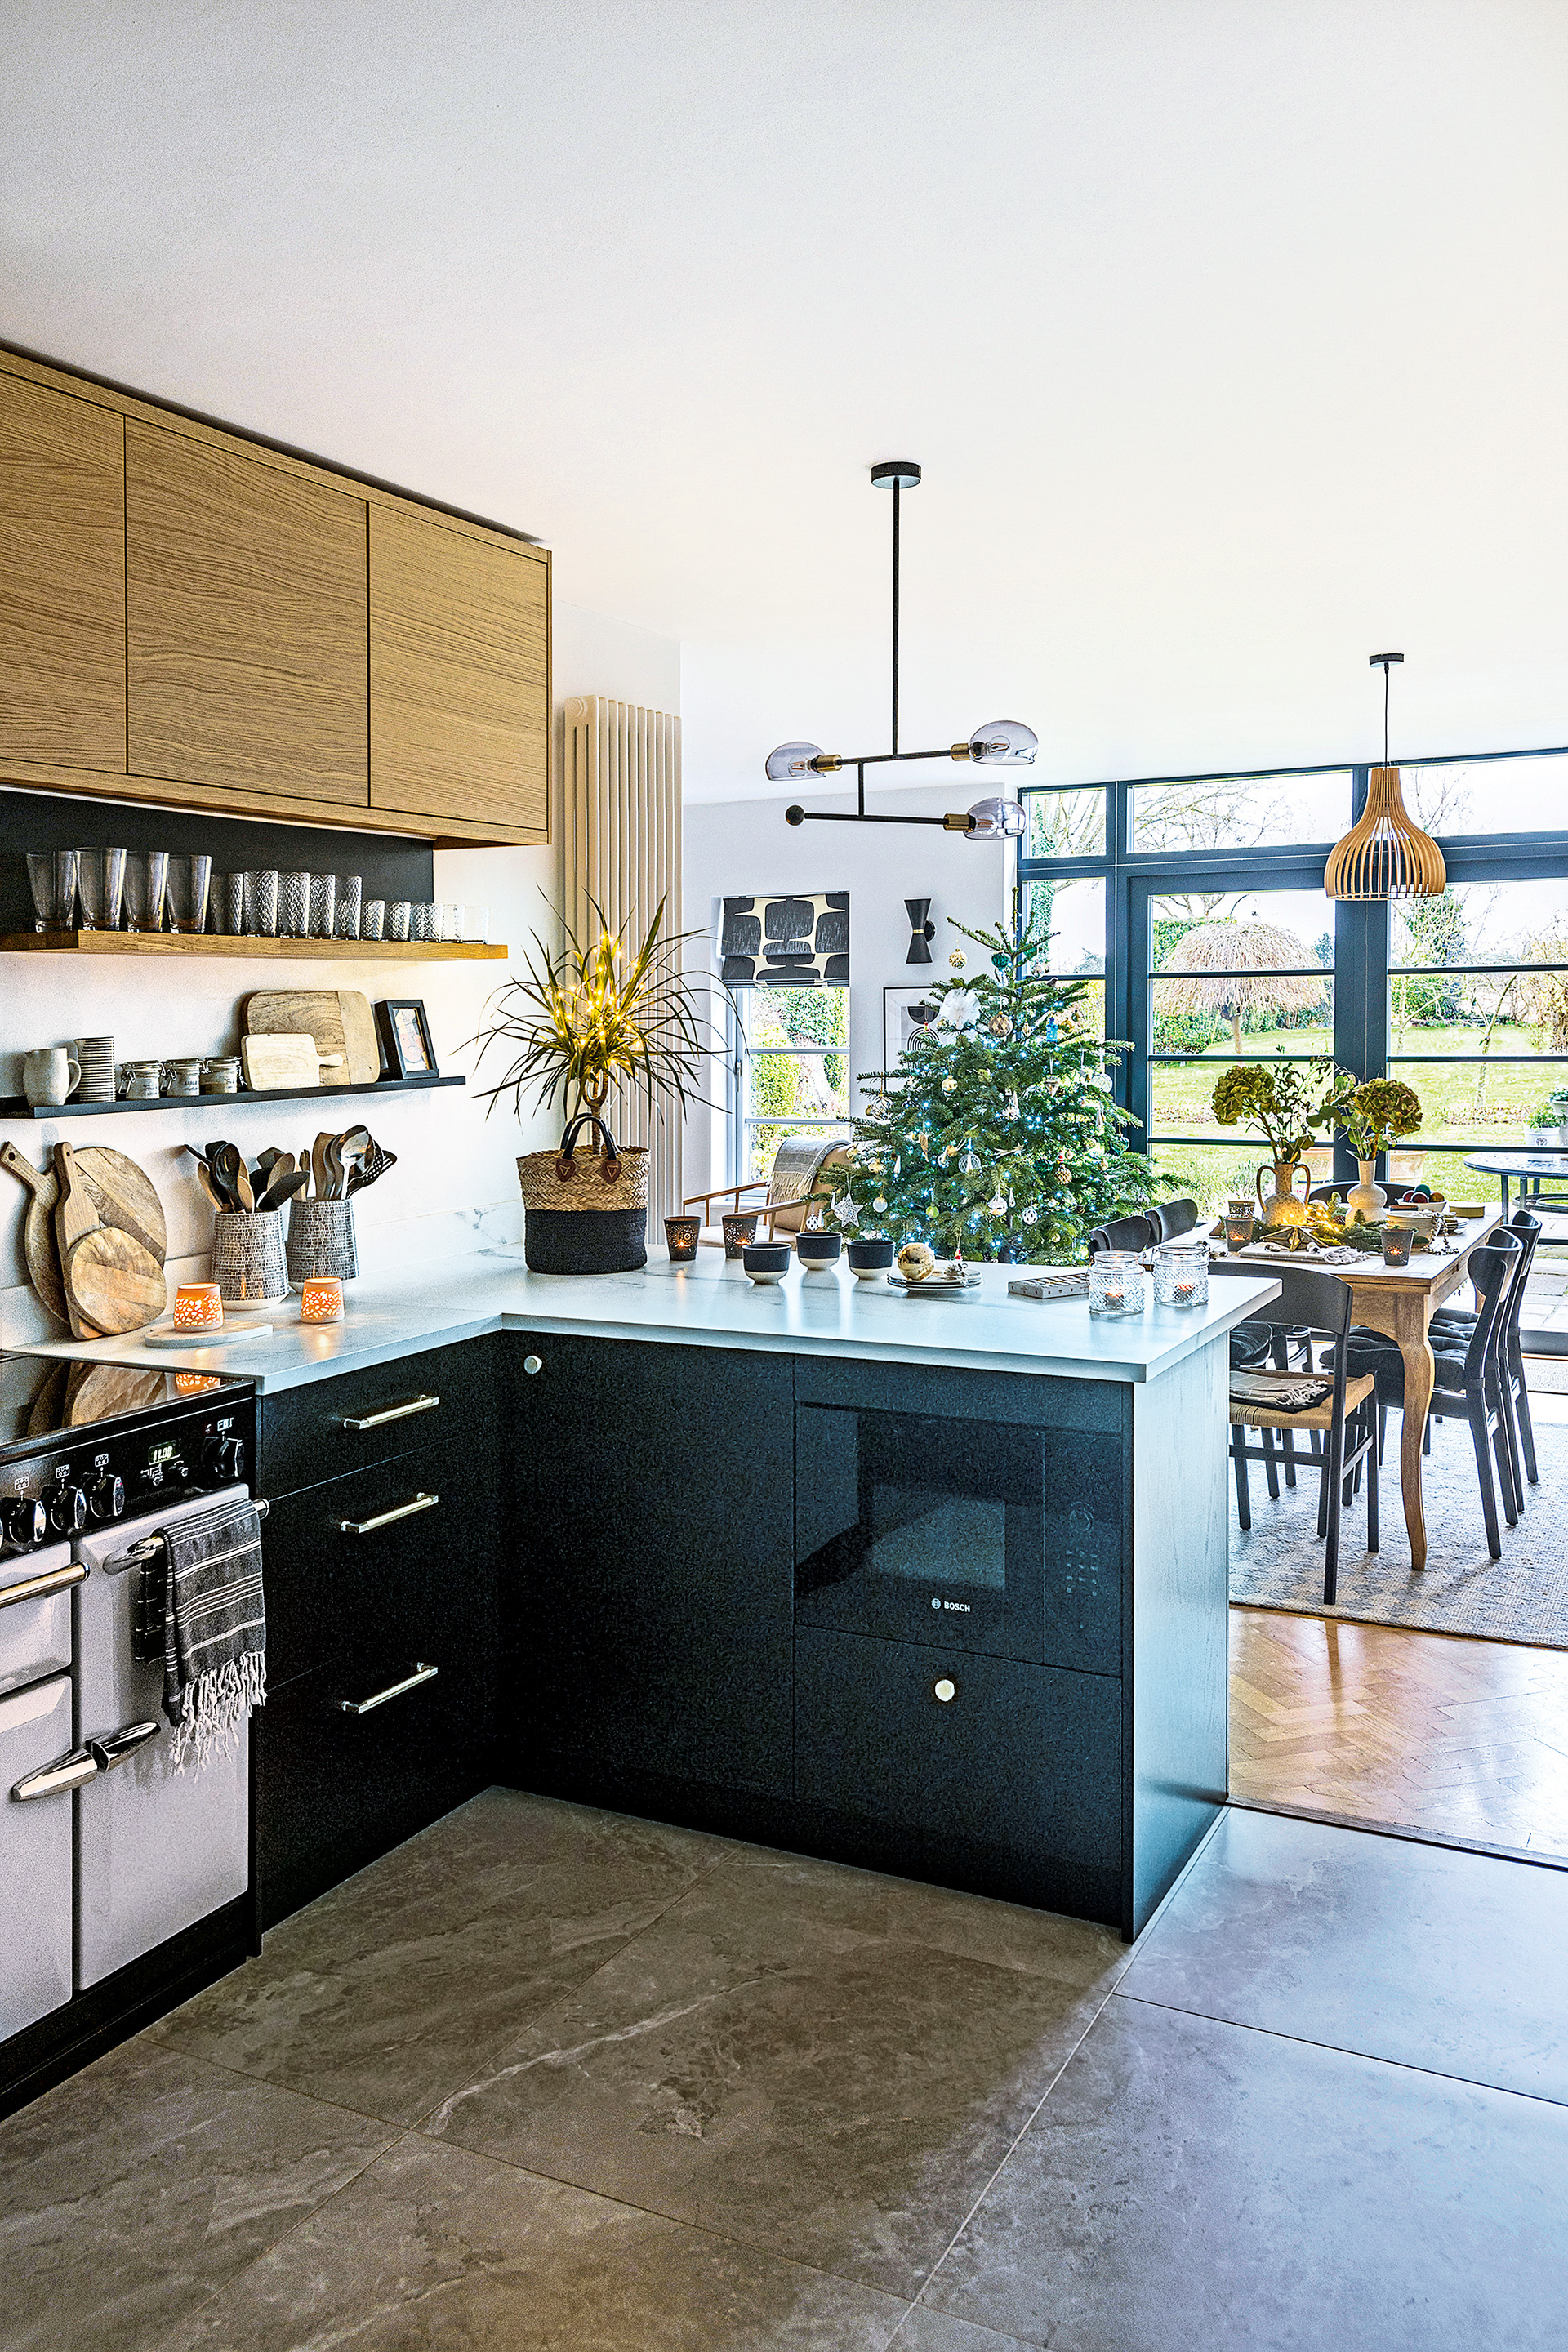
left=559, top=694, right=682, bottom=1242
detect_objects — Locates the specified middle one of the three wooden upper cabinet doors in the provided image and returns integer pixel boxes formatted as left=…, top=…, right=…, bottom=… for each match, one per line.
left=125, top=419, right=369, bottom=809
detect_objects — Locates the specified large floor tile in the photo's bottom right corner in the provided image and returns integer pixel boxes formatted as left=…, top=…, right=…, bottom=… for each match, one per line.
left=924, top=1999, right=1568, bottom=2352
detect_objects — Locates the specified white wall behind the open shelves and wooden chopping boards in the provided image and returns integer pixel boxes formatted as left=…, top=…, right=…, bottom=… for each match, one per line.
left=0, top=604, right=679, bottom=1345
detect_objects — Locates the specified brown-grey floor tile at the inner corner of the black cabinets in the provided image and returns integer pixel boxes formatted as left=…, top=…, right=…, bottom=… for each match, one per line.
left=155, top=1790, right=728, bottom=2124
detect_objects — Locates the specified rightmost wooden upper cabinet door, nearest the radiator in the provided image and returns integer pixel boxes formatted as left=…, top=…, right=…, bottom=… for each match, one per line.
left=369, top=506, right=550, bottom=840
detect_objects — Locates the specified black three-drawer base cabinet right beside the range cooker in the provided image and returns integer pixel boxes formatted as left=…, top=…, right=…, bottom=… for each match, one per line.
left=254, top=1336, right=506, bottom=1929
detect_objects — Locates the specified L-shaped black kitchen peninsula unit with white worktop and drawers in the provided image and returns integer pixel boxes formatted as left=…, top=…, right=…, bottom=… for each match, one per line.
left=21, top=1251, right=1274, bottom=1938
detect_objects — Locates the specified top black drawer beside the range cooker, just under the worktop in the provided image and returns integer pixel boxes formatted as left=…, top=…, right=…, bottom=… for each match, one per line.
left=259, top=1336, right=501, bottom=1500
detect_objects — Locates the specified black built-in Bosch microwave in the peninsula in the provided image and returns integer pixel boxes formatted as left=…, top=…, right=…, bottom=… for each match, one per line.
left=795, top=1404, right=1121, bottom=1673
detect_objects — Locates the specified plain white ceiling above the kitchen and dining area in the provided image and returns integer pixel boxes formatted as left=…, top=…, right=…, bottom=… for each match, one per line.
left=0, top=0, right=1568, bottom=797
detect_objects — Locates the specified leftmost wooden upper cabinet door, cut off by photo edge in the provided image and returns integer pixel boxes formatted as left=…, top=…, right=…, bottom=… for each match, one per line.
left=0, top=374, right=125, bottom=776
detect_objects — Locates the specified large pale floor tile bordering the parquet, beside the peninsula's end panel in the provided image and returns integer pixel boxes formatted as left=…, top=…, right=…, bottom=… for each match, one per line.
left=1121, top=1811, right=1568, bottom=2100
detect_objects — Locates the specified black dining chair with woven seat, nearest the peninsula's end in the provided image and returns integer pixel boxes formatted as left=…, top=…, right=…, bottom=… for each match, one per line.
left=1229, top=1265, right=1378, bottom=1606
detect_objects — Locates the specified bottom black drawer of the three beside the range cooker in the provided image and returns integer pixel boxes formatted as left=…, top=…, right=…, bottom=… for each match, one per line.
left=254, top=1654, right=489, bottom=1929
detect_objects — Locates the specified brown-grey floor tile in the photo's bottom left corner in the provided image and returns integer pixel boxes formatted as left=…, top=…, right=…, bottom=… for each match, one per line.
left=0, top=2039, right=395, bottom=2352
